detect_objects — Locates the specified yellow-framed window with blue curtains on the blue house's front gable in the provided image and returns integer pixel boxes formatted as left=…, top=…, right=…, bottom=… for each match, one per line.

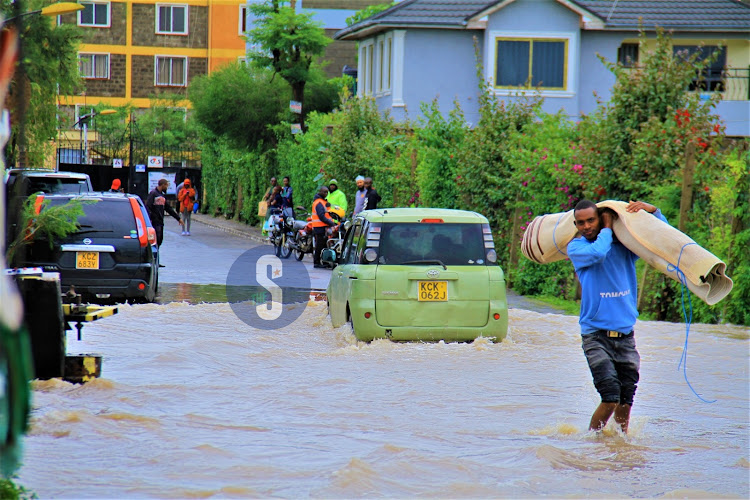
left=495, top=38, right=568, bottom=90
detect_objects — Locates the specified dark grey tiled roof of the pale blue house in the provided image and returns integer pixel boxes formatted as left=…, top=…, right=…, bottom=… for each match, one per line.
left=334, top=0, right=750, bottom=40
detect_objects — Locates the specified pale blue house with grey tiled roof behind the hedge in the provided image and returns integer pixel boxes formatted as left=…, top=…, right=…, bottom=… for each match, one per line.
left=335, top=0, right=750, bottom=137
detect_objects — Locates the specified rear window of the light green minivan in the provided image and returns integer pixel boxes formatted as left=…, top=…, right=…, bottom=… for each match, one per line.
left=379, top=222, right=486, bottom=266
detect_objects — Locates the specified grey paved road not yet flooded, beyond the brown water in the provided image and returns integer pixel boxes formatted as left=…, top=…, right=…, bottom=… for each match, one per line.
left=157, top=214, right=562, bottom=314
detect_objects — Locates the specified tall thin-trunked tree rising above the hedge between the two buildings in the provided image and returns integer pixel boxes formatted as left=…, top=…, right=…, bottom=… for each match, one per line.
left=247, top=0, right=331, bottom=130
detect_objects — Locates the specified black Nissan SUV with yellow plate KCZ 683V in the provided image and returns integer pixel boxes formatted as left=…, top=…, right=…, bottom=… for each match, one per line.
left=14, top=192, right=159, bottom=302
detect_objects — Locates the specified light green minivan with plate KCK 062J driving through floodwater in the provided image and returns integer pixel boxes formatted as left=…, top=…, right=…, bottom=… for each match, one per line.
left=322, top=208, right=508, bottom=342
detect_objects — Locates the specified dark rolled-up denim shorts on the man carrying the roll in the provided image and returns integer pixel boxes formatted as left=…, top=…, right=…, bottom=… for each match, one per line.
left=581, top=330, right=641, bottom=405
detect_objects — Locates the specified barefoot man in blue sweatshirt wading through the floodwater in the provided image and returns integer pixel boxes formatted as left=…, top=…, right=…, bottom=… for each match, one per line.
left=568, top=200, right=667, bottom=433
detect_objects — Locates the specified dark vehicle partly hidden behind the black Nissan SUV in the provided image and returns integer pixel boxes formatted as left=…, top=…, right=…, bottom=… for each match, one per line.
left=5, top=168, right=93, bottom=242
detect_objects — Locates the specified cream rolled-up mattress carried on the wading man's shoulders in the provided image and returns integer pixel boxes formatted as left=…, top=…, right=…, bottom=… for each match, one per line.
left=521, top=200, right=733, bottom=305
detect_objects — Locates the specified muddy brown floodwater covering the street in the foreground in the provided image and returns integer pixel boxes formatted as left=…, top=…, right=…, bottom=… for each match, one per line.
left=17, top=298, right=750, bottom=498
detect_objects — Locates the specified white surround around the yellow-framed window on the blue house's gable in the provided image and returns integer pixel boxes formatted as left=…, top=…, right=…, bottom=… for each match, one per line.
left=484, top=31, right=581, bottom=97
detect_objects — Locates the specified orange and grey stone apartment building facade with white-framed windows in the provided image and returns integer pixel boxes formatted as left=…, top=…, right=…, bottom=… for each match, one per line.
left=59, top=0, right=247, bottom=128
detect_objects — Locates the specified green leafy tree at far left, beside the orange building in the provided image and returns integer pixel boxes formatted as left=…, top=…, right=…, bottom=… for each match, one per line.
left=0, top=0, right=82, bottom=167
